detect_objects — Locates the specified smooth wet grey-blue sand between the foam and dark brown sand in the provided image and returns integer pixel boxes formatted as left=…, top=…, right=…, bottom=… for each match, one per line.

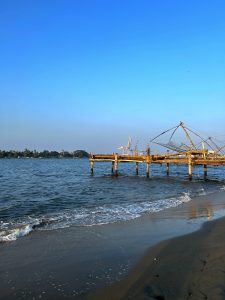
left=0, top=191, right=225, bottom=300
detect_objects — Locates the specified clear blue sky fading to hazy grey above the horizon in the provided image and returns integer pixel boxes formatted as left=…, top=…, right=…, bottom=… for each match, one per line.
left=0, top=0, right=225, bottom=153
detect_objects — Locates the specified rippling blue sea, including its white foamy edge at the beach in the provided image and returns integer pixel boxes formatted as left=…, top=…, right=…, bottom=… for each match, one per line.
left=0, top=159, right=225, bottom=242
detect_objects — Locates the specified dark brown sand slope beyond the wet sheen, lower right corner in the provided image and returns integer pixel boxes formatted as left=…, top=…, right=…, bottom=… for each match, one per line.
left=89, top=218, right=225, bottom=300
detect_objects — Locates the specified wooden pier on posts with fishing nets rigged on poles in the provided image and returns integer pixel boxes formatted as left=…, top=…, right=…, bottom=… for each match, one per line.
left=89, top=122, right=225, bottom=180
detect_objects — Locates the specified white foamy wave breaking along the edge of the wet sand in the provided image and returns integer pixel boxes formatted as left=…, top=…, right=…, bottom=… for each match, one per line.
left=0, top=193, right=191, bottom=242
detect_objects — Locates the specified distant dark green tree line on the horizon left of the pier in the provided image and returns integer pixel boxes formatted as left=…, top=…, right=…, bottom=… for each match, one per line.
left=0, top=149, right=89, bottom=158
